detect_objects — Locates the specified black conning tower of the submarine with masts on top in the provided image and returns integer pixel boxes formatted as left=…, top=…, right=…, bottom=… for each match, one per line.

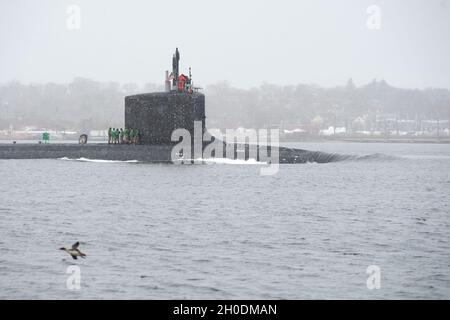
left=125, top=48, right=206, bottom=145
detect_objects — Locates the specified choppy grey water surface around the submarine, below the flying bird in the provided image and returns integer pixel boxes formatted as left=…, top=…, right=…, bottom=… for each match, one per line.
left=0, top=143, right=450, bottom=299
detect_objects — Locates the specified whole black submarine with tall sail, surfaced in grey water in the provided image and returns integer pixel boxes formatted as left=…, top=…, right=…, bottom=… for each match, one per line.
left=0, top=48, right=352, bottom=164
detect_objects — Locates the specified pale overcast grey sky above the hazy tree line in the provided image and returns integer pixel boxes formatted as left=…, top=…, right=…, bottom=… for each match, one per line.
left=0, top=0, right=450, bottom=88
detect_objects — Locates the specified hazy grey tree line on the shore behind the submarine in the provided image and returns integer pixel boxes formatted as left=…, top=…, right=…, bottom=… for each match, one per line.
left=0, top=78, right=450, bottom=131
